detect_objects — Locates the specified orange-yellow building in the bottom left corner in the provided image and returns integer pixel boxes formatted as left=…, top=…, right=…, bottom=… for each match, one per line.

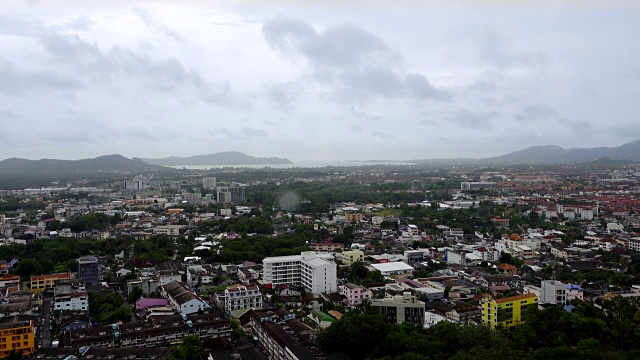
left=0, top=316, right=35, bottom=358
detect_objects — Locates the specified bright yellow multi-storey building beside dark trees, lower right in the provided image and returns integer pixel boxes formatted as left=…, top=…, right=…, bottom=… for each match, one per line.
left=482, top=294, right=538, bottom=329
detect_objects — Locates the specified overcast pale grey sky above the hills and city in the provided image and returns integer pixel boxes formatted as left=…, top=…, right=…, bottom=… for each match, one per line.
left=0, top=0, right=640, bottom=161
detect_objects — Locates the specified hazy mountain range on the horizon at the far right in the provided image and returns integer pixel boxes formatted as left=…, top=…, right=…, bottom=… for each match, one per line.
left=483, top=140, right=640, bottom=164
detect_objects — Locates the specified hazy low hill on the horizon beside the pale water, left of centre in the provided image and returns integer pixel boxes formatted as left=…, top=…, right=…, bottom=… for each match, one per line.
left=142, top=151, right=293, bottom=166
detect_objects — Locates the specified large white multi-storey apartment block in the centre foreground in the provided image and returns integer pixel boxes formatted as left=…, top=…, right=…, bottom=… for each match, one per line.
left=262, top=251, right=338, bottom=294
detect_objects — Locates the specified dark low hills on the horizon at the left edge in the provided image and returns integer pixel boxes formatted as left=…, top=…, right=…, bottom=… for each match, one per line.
left=0, top=154, right=168, bottom=174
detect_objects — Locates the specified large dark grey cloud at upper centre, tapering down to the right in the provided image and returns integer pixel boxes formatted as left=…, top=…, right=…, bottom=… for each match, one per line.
left=263, top=18, right=447, bottom=102
